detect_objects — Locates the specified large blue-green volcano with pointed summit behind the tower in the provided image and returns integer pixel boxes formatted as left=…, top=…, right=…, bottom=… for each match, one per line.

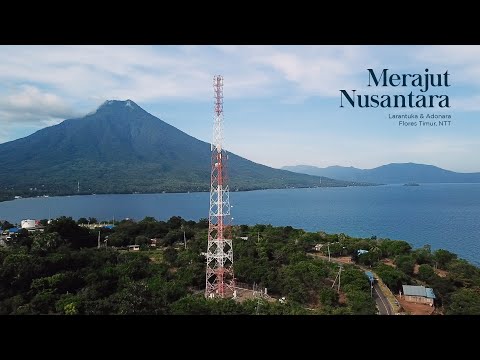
left=0, top=100, right=362, bottom=199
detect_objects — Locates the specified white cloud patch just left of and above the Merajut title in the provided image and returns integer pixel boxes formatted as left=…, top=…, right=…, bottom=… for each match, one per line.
left=219, top=45, right=377, bottom=99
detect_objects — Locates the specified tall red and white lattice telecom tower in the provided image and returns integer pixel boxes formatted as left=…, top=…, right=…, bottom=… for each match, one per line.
left=205, top=75, right=235, bottom=298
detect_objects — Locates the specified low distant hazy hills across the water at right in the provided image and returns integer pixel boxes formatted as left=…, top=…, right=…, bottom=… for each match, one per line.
left=282, top=163, right=480, bottom=184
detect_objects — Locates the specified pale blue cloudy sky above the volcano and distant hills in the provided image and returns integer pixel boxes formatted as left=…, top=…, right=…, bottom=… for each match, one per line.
left=0, top=45, right=480, bottom=172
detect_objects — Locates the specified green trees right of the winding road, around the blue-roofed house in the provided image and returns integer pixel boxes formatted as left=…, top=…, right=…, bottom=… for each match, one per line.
left=325, top=234, right=480, bottom=315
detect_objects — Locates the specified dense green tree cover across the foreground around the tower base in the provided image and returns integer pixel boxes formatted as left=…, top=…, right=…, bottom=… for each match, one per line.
left=0, top=217, right=480, bottom=314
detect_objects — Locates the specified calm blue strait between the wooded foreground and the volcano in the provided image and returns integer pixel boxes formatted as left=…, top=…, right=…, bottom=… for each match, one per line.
left=0, top=184, right=480, bottom=265
